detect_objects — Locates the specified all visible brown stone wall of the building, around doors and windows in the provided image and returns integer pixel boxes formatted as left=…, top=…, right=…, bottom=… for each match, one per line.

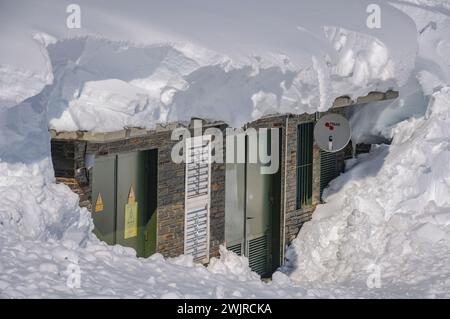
left=52, top=109, right=352, bottom=264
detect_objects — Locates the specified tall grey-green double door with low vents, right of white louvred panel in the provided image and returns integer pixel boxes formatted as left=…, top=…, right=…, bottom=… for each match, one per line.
left=225, top=130, right=281, bottom=277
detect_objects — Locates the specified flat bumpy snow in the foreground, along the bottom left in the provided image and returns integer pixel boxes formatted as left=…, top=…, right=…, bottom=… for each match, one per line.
left=0, top=236, right=288, bottom=299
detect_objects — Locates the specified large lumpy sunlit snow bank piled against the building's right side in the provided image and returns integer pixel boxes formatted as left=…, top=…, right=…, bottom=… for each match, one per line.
left=289, top=87, right=450, bottom=297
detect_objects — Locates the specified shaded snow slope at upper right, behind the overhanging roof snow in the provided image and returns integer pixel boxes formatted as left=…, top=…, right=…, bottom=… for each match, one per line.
left=350, top=1, right=450, bottom=143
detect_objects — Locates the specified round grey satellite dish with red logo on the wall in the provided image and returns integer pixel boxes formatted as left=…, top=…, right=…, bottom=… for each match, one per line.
left=314, top=113, right=352, bottom=153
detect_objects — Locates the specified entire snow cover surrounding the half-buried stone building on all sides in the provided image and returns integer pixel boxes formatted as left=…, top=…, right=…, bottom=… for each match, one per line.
left=0, top=0, right=450, bottom=298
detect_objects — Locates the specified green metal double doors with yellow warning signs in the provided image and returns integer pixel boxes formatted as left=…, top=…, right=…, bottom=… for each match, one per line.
left=92, top=150, right=158, bottom=257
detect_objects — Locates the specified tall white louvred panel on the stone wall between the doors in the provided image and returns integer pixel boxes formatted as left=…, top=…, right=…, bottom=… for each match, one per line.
left=184, top=136, right=211, bottom=262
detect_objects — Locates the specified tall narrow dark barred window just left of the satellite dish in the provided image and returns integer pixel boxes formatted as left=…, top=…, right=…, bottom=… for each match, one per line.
left=297, top=122, right=314, bottom=209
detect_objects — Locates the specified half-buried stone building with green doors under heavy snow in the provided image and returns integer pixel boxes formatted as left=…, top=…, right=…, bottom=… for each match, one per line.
left=51, top=91, right=398, bottom=276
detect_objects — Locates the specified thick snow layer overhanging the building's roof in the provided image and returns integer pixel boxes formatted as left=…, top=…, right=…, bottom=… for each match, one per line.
left=0, top=0, right=416, bottom=132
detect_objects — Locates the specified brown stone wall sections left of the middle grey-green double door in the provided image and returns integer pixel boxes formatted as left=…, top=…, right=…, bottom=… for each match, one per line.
left=51, top=124, right=225, bottom=257
